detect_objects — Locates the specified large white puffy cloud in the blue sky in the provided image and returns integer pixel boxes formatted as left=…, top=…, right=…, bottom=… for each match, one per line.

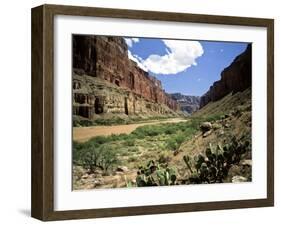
left=141, top=40, right=204, bottom=74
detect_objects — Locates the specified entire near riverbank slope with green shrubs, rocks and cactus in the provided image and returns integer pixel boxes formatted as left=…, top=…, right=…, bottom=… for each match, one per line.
left=73, top=99, right=251, bottom=189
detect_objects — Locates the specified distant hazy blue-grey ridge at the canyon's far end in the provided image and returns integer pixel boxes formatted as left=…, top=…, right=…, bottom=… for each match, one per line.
left=170, top=93, right=200, bottom=114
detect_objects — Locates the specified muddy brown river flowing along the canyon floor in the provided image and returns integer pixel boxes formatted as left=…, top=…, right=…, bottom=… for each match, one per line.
left=73, top=118, right=186, bottom=142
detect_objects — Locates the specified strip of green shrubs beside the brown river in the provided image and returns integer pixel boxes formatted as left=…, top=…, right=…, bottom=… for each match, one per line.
left=73, top=117, right=222, bottom=177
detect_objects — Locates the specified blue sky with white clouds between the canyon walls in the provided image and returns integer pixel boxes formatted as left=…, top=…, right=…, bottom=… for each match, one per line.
left=125, top=38, right=247, bottom=96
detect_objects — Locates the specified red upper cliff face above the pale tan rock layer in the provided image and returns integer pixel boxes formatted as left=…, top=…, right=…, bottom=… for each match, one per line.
left=73, top=35, right=179, bottom=111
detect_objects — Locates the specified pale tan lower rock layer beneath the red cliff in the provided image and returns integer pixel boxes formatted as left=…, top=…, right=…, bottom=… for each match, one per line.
left=73, top=73, right=175, bottom=119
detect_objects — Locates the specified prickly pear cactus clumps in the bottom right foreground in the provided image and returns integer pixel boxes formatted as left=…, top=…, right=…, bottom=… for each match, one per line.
left=136, top=135, right=251, bottom=187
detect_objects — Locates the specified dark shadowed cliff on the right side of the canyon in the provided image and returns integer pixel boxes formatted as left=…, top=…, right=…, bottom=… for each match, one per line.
left=200, top=44, right=252, bottom=108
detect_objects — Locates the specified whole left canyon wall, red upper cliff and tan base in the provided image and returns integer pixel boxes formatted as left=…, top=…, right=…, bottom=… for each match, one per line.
left=73, top=35, right=179, bottom=119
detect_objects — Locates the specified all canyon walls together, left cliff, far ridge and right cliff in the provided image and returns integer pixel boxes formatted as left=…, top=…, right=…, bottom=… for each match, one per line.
left=72, top=35, right=251, bottom=120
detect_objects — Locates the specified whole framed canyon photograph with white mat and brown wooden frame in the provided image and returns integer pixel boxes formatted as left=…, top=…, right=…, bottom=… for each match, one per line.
left=32, top=5, right=274, bottom=221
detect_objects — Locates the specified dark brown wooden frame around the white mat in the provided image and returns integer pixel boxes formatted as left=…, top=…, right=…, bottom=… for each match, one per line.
left=31, top=5, right=274, bottom=221
